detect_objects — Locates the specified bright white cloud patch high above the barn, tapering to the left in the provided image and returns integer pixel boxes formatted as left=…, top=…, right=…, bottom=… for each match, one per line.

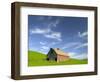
left=44, top=32, right=62, bottom=41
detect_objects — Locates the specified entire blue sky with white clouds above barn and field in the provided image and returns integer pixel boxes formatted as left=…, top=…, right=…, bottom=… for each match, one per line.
left=28, top=15, right=88, bottom=59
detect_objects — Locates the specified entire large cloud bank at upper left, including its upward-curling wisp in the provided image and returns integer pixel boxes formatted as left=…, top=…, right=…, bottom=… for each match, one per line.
left=30, top=20, right=62, bottom=41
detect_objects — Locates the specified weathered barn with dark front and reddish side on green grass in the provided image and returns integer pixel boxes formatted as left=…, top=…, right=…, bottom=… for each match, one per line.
left=47, top=48, right=69, bottom=62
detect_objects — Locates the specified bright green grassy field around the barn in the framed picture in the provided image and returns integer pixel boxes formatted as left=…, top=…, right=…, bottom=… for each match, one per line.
left=28, top=51, right=88, bottom=66
